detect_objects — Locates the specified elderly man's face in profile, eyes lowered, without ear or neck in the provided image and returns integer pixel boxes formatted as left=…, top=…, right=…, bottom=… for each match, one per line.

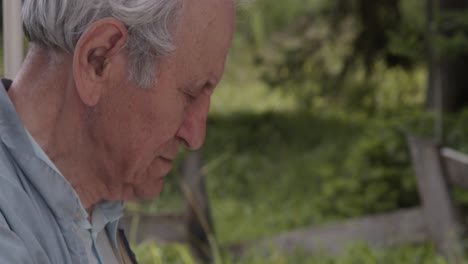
left=86, top=0, right=234, bottom=200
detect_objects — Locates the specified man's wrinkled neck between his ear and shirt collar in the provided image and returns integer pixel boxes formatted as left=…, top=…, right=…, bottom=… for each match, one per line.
left=8, top=45, right=105, bottom=211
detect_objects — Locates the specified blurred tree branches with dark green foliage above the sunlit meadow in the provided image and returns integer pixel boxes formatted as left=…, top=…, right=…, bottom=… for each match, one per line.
left=239, top=0, right=425, bottom=113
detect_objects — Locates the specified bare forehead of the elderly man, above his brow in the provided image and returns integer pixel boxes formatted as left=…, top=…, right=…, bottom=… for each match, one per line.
left=166, top=0, right=234, bottom=79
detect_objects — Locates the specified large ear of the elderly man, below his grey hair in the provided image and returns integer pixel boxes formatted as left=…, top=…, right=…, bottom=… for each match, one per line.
left=73, top=18, right=128, bottom=106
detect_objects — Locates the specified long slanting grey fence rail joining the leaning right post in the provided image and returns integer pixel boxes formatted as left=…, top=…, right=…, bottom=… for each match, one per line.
left=228, top=208, right=429, bottom=254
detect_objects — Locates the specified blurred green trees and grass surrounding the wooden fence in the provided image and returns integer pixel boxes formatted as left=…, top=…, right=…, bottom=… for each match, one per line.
left=4, top=0, right=468, bottom=264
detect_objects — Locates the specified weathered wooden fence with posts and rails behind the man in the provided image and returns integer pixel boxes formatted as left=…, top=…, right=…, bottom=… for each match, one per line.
left=123, top=137, right=468, bottom=263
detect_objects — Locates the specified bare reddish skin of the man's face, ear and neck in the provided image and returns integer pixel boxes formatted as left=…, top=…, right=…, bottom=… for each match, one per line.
left=9, top=0, right=238, bottom=208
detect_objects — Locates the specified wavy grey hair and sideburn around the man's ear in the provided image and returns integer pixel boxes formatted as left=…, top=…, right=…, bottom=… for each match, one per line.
left=22, top=0, right=181, bottom=87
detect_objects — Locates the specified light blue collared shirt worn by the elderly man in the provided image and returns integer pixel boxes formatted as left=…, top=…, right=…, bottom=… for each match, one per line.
left=0, top=79, right=122, bottom=264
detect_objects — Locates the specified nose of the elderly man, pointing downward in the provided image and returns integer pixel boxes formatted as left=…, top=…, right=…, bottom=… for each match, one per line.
left=177, top=100, right=209, bottom=150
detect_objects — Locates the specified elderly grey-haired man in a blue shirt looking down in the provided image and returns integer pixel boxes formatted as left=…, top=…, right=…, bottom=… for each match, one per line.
left=0, top=0, right=234, bottom=264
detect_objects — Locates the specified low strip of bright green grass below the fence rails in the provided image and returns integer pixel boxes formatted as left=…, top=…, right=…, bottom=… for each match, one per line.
left=136, top=243, right=449, bottom=264
